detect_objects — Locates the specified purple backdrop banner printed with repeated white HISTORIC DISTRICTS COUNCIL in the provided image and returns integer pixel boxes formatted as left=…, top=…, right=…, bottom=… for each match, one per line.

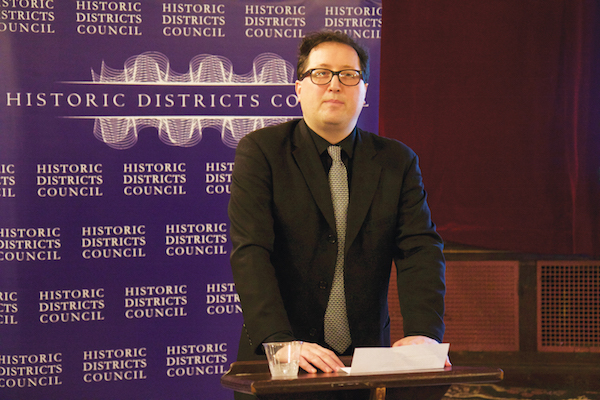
left=0, top=0, right=382, bottom=400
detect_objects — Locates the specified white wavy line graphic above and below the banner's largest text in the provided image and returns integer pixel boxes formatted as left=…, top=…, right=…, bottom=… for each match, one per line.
left=87, top=52, right=298, bottom=150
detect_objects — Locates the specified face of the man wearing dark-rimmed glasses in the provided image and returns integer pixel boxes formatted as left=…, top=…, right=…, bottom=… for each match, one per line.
left=296, top=42, right=367, bottom=143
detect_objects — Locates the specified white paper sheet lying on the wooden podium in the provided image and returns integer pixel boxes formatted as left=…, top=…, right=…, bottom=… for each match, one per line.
left=344, top=343, right=450, bottom=375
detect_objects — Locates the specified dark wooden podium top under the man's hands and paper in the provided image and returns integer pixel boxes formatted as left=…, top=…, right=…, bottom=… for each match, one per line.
left=221, top=357, right=504, bottom=400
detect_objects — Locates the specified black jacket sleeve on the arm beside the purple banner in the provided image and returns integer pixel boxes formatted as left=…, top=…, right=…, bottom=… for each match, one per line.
left=228, top=135, right=293, bottom=353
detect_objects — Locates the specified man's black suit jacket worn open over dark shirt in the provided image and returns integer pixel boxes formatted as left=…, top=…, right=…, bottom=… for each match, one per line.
left=229, top=120, right=445, bottom=360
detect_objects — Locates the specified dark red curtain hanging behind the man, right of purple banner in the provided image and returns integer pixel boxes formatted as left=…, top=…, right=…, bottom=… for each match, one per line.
left=380, top=0, right=600, bottom=256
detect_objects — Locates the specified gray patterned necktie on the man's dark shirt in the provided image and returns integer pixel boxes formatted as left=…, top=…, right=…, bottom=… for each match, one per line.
left=325, top=146, right=352, bottom=353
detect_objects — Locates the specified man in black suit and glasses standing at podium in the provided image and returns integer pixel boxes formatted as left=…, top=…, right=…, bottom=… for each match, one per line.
left=229, top=32, right=445, bottom=400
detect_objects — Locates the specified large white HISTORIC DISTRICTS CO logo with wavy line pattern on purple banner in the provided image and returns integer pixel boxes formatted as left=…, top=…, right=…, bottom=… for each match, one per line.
left=5, top=52, right=300, bottom=150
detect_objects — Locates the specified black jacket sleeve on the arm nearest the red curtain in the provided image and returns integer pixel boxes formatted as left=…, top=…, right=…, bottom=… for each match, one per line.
left=394, top=153, right=446, bottom=342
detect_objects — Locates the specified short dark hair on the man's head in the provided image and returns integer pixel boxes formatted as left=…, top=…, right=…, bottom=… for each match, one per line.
left=296, top=31, right=369, bottom=82
